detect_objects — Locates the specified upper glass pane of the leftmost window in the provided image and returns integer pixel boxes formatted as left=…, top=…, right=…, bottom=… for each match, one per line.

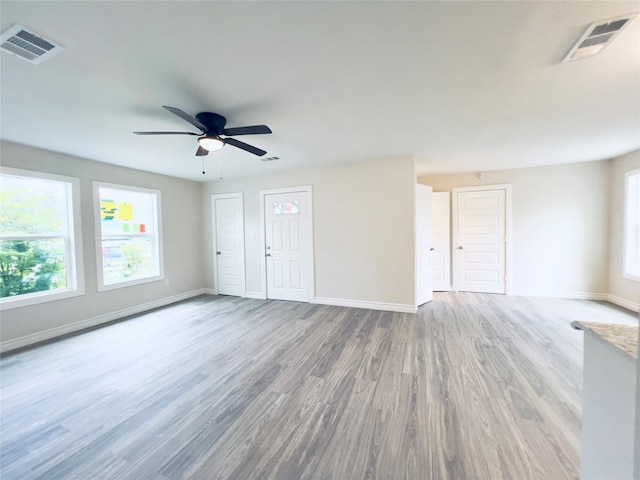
left=0, top=175, right=68, bottom=235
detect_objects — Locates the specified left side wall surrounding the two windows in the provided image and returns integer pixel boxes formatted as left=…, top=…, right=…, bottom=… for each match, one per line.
left=0, top=142, right=204, bottom=350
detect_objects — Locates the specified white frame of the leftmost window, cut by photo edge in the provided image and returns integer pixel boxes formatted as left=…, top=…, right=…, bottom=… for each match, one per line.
left=0, top=166, right=85, bottom=311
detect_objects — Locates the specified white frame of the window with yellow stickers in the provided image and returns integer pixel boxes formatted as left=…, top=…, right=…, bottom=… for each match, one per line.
left=93, top=182, right=164, bottom=292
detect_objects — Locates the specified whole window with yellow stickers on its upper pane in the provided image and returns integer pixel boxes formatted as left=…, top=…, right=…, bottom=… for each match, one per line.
left=93, top=182, right=164, bottom=291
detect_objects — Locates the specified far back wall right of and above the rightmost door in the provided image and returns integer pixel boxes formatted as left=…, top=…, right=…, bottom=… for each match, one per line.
left=418, top=161, right=610, bottom=298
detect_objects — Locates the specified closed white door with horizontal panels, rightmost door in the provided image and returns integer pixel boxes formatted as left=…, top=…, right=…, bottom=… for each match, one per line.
left=453, top=187, right=507, bottom=293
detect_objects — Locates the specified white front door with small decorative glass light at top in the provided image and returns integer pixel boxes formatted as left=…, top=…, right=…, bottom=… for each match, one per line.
left=264, top=191, right=312, bottom=302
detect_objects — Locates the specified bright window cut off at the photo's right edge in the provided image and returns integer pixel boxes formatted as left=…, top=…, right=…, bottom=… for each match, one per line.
left=622, top=168, right=640, bottom=281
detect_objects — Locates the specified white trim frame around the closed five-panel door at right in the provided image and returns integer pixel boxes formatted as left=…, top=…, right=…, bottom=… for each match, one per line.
left=451, top=183, right=513, bottom=295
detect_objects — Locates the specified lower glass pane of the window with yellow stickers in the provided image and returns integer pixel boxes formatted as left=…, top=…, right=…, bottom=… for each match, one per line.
left=102, top=236, right=158, bottom=285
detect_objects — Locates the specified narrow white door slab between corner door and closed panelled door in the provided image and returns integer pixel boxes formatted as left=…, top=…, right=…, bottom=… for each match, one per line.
left=431, top=192, right=451, bottom=292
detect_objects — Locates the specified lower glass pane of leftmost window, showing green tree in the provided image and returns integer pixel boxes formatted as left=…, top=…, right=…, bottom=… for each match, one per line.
left=0, top=238, right=67, bottom=297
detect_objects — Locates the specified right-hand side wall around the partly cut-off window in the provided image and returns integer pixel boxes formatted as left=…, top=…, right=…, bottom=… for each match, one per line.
left=609, top=151, right=640, bottom=305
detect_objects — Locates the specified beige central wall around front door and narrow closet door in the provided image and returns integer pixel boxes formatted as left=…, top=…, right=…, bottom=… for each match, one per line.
left=202, top=157, right=415, bottom=309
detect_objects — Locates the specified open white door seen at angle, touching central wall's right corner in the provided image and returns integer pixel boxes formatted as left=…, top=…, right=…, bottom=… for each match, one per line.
left=415, top=185, right=433, bottom=306
